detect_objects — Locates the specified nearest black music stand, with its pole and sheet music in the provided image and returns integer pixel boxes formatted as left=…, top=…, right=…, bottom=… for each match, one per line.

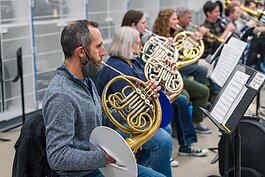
left=200, top=64, right=265, bottom=177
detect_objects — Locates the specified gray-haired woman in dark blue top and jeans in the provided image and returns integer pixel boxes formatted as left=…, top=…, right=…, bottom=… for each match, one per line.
left=97, top=26, right=172, bottom=177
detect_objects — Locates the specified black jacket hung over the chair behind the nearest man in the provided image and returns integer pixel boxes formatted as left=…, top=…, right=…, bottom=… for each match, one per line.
left=12, top=113, right=56, bottom=177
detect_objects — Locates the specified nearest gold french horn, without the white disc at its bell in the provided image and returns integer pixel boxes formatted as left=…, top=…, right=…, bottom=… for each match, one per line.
left=101, top=61, right=162, bottom=153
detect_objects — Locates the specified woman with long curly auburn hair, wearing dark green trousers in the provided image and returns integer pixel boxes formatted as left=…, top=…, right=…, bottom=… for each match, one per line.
left=153, top=9, right=212, bottom=134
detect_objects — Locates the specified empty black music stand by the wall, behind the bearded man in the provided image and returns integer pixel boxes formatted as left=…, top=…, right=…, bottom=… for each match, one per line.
left=2, top=47, right=26, bottom=132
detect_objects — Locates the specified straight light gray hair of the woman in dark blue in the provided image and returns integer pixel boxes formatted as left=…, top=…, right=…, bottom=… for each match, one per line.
left=109, top=26, right=140, bottom=59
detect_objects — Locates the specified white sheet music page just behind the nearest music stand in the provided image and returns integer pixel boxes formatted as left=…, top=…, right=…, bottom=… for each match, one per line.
left=210, top=37, right=247, bottom=87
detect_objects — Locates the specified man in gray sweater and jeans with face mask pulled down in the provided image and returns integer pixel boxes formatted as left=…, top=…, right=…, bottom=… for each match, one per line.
left=42, top=20, right=164, bottom=177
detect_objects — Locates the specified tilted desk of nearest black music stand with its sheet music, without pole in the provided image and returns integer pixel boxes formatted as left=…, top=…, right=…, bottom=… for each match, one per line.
left=200, top=64, right=265, bottom=134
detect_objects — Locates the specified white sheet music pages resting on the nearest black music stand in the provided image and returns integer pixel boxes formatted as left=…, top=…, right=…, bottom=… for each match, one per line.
left=210, top=71, right=250, bottom=124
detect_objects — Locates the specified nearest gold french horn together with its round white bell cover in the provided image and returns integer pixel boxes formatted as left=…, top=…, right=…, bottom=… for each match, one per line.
left=90, top=61, right=162, bottom=177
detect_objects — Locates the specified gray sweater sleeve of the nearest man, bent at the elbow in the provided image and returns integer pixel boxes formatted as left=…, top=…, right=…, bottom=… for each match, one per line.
left=43, top=93, right=106, bottom=170
